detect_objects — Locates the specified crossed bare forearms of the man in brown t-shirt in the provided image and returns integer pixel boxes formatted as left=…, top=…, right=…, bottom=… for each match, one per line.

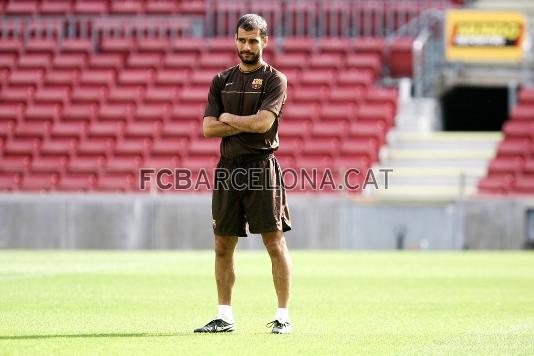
left=202, top=110, right=276, bottom=137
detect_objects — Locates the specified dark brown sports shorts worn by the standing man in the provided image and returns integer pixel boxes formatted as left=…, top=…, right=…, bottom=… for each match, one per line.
left=211, top=154, right=291, bottom=236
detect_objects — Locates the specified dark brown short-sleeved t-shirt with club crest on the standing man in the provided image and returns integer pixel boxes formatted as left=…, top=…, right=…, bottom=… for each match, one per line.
left=204, top=63, right=287, bottom=158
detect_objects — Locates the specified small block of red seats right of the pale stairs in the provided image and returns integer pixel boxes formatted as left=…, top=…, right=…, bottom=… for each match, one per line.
left=478, top=88, right=534, bottom=195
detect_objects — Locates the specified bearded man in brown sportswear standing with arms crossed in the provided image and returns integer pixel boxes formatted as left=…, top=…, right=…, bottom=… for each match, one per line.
left=195, top=14, right=291, bottom=334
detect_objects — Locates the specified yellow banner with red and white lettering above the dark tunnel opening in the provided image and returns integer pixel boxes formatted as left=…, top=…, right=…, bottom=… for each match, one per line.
left=445, top=10, right=528, bottom=62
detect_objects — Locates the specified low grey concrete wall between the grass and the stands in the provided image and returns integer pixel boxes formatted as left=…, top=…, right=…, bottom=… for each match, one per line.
left=0, top=194, right=534, bottom=250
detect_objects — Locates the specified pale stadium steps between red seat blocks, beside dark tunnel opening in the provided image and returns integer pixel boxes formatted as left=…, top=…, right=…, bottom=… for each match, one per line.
left=364, top=98, right=501, bottom=200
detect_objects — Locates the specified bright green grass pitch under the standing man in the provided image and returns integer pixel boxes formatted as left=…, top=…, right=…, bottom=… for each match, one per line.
left=0, top=251, right=534, bottom=356
